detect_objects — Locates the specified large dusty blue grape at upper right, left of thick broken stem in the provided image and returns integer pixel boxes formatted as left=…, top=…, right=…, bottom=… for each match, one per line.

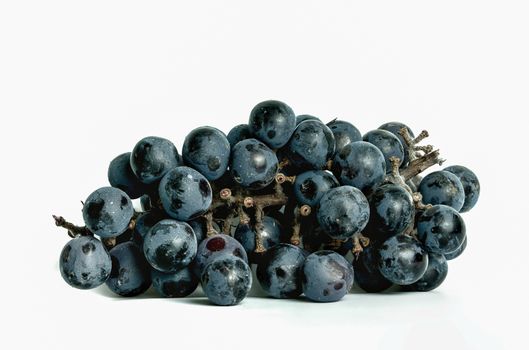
left=332, top=141, right=386, bottom=192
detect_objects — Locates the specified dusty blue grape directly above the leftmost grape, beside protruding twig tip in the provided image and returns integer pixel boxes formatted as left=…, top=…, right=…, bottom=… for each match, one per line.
left=83, top=187, right=134, bottom=238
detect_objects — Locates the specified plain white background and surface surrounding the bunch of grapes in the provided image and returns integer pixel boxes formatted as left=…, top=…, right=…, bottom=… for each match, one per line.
left=0, top=0, right=529, bottom=350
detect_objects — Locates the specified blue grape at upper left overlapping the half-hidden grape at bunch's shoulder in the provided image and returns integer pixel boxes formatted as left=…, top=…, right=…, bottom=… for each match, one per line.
left=130, top=136, right=182, bottom=184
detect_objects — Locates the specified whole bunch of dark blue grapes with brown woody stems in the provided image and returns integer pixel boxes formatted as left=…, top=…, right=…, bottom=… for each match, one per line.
left=54, top=101, right=480, bottom=305
